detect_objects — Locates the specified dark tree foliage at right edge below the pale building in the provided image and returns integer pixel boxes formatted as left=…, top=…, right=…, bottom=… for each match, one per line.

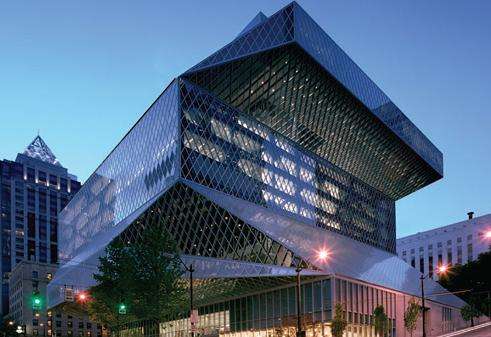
left=439, top=251, right=491, bottom=315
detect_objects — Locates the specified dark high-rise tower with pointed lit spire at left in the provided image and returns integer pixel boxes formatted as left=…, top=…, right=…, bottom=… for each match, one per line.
left=0, top=135, right=80, bottom=319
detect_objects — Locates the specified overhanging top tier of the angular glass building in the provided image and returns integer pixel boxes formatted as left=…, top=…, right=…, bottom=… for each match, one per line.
left=183, top=2, right=443, bottom=199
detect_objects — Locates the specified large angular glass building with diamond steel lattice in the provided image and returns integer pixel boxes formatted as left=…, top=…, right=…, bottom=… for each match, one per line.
left=48, top=3, right=463, bottom=337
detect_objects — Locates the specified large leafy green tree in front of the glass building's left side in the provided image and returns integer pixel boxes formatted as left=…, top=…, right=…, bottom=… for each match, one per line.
left=88, top=223, right=187, bottom=326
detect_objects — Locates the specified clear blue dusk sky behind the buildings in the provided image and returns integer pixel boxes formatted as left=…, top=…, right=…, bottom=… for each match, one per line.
left=0, top=0, right=491, bottom=237
